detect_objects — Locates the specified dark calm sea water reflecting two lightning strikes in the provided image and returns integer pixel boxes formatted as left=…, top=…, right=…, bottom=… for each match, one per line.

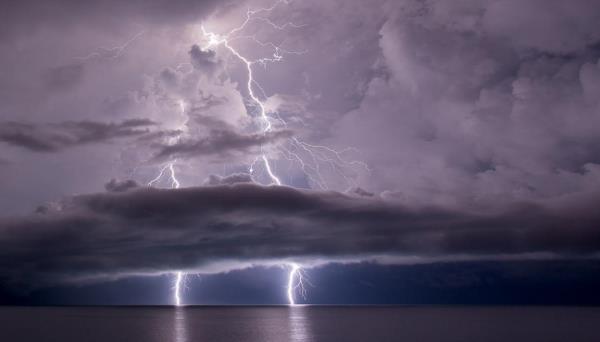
left=0, top=306, right=600, bottom=342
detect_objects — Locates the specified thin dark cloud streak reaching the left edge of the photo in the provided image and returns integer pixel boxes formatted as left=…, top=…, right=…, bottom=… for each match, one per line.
left=0, top=119, right=154, bottom=152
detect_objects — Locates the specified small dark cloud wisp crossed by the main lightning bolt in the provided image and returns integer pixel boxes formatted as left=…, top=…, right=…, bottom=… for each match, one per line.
left=155, top=130, right=292, bottom=160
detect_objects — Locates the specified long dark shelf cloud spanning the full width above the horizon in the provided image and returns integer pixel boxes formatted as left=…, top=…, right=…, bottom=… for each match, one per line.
left=0, top=183, right=600, bottom=283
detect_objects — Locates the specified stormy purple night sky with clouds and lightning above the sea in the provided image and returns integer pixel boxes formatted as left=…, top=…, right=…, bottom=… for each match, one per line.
left=0, top=0, right=600, bottom=305
